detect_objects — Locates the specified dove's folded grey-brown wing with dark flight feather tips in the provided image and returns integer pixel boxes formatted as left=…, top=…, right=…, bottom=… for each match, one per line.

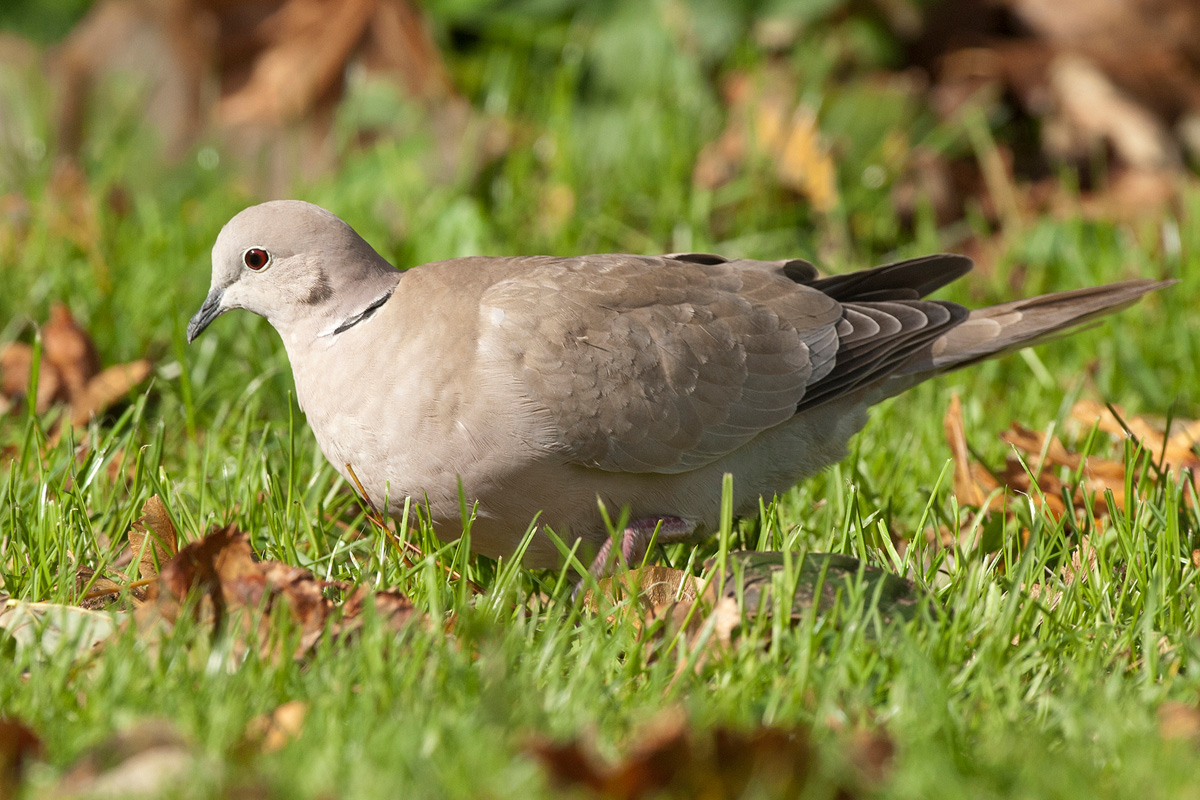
left=481, top=254, right=955, bottom=473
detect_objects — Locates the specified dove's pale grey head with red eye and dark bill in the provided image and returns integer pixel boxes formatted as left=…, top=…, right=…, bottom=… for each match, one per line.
left=187, top=200, right=397, bottom=342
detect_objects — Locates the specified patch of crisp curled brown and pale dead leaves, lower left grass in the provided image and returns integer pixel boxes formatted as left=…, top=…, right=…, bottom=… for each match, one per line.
left=0, top=497, right=418, bottom=658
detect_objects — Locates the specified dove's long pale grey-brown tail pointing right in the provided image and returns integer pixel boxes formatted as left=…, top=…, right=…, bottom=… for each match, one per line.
left=884, top=279, right=1175, bottom=395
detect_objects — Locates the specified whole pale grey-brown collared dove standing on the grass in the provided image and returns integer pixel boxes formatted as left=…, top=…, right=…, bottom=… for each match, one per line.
left=187, top=200, right=1165, bottom=570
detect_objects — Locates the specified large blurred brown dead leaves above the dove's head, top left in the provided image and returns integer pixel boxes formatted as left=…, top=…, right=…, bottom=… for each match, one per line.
left=50, top=0, right=458, bottom=190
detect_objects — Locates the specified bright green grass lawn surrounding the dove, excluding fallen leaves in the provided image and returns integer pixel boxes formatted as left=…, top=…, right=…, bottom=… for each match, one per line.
left=0, top=4, right=1200, bottom=799
